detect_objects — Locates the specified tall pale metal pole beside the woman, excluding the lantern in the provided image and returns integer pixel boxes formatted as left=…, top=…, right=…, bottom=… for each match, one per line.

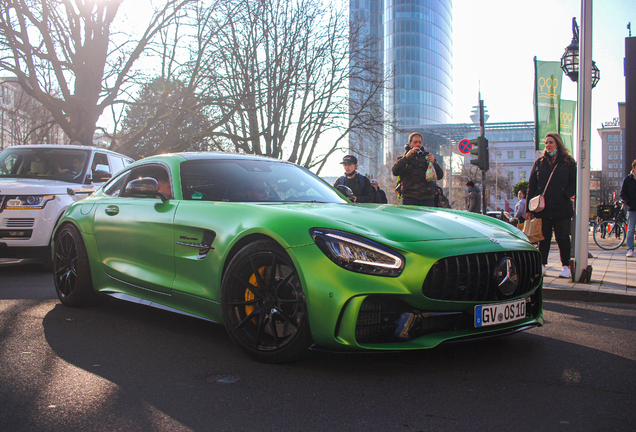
left=574, top=0, right=592, bottom=282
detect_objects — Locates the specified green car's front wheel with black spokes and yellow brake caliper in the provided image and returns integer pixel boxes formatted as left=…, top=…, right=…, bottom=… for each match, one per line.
left=221, top=240, right=312, bottom=363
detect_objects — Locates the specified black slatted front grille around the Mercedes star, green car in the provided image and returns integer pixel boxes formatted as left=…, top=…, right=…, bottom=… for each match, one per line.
left=422, top=251, right=541, bottom=302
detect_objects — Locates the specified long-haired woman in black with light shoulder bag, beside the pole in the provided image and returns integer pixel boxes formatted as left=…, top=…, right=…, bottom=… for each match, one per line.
left=527, top=132, right=576, bottom=278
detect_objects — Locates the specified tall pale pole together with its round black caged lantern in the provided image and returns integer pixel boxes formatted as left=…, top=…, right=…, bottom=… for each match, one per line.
left=561, top=0, right=601, bottom=282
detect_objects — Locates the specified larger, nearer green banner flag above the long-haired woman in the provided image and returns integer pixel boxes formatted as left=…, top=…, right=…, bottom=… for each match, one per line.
left=534, top=57, right=563, bottom=150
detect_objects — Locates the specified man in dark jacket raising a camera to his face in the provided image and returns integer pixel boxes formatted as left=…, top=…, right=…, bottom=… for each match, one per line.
left=392, top=132, right=444, bottom=207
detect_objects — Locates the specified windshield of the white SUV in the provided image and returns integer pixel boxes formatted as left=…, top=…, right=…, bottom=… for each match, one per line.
left=0, top=147, right=90, bottom=183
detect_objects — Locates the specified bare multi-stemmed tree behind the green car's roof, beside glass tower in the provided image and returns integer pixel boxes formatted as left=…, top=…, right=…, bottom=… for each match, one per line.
left=201, top=0, right=383, bottom=173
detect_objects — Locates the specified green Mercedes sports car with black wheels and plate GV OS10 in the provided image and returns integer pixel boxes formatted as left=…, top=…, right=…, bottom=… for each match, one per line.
left=53, top=153, right=543, bottom=363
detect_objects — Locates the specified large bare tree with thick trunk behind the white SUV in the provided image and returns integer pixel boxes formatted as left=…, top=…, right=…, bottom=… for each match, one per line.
left=0, top=0, right=193, bottom=144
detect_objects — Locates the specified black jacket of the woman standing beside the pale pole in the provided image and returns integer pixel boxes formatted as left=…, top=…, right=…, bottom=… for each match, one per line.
left=526, top=154, right=576, bottom=219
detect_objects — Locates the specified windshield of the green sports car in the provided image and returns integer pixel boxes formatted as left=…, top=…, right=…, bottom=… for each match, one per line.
left=181, top=159, right=345, bottom=203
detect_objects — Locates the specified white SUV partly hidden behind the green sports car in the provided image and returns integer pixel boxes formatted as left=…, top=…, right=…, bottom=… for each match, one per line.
left=0, top=145, right=133, bottom=269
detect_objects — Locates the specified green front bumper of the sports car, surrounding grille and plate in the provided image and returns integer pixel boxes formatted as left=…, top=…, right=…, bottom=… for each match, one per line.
left=293, top=238, right=543, bottom=350
